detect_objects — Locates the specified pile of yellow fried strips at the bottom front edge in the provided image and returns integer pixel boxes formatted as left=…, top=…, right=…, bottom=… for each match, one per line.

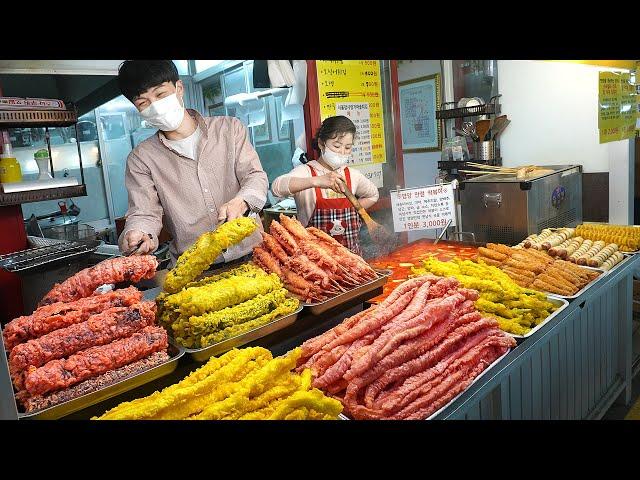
left=98, top=347, right=342, bottom=420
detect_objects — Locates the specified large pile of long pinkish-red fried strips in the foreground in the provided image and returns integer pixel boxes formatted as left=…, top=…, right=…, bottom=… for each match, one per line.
left=298, top=275, right=516, bottom=420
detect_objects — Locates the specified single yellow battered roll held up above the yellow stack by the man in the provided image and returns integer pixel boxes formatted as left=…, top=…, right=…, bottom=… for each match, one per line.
left=164, top=217, right=257, bottom=293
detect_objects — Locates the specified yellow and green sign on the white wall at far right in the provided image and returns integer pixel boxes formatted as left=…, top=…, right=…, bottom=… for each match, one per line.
left=598, top=72, right=637, bottom=143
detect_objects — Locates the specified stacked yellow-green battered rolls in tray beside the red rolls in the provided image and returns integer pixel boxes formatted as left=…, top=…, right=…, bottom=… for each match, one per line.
left=156, top=264, right=300, bottom=348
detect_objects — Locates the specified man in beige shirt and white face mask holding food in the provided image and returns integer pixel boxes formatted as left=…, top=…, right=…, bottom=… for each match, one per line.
left=118, top=60, right=268, bottom=263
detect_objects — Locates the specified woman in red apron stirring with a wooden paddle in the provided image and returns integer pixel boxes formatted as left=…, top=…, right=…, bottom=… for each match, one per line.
left=271, top=116, right=378, bottom=254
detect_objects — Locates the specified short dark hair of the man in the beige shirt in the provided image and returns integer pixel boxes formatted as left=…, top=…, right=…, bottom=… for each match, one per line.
left=118, top=60, right=180, bottom=102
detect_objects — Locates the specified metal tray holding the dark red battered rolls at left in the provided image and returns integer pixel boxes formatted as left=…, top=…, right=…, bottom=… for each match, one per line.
left=18, top=340, right=184, bottom=420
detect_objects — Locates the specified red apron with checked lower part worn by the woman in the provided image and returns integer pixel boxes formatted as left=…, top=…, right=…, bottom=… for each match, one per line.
left=308, top=165, right=362, bottom=255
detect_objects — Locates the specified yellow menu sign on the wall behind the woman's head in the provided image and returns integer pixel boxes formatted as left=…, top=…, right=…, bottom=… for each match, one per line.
left=316, top=60, right=386, bottom=165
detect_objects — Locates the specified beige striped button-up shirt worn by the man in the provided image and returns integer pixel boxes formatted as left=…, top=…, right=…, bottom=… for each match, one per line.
left=118, top=109, right=269, bottom=261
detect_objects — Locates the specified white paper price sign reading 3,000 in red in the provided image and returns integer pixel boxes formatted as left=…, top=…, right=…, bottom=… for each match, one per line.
left=389, top=183, right=456, bottom=232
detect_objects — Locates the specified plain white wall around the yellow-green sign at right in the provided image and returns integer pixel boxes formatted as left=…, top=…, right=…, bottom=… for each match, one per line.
left=498, top=60, right=633, bottom=223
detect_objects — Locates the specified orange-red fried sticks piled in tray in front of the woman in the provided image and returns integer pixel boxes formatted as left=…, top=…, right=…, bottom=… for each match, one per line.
left=253, top=214, right=378, bottom=303
